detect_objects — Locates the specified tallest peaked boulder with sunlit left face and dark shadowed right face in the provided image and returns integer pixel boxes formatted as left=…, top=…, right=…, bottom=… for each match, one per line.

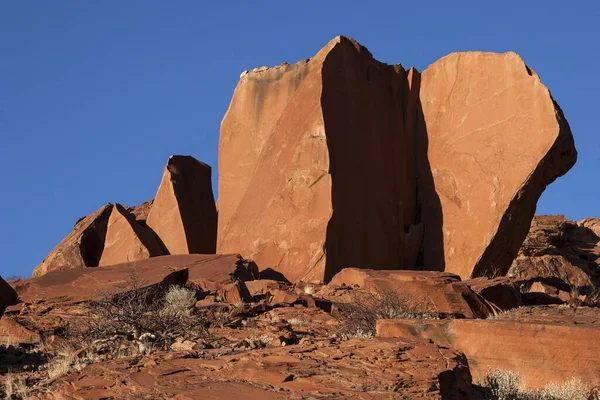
left=218, top=37, right=420, bottom=282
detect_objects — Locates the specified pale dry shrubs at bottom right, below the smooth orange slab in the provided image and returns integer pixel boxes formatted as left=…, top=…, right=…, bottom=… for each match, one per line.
left=484, top=369, right=598, bottom=400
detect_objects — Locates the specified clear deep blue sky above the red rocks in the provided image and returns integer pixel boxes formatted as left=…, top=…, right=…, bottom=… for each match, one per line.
left=0, top=0, right=600, bottom=276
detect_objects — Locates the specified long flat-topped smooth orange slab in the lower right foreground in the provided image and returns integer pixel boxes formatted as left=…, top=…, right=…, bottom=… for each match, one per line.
left=377, top=320, right=600, bottom=388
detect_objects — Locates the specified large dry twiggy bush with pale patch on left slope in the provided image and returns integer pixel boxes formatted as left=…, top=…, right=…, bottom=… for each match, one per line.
left=72, top=273, right=206, bottom=356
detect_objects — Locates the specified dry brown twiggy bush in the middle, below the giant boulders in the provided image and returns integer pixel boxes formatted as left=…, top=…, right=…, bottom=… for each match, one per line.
left=337, top=289, right=435, bottom=339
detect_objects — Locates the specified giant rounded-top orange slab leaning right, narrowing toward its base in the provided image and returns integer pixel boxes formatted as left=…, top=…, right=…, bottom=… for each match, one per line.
left=418, top=52, right=577, bottom=279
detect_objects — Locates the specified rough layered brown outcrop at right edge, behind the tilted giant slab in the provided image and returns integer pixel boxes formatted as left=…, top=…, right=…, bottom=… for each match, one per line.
left=509, top=215, right=600, bottom=291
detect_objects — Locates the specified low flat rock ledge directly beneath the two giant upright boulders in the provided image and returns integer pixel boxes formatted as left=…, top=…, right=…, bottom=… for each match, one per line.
left=330, top=268, right=493, bottom=318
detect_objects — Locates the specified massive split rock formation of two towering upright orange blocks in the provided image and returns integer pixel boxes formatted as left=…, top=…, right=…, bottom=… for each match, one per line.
left=218, top=37, right=576, bottom=281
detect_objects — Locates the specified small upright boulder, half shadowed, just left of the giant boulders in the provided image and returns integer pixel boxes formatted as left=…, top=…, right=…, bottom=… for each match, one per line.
left=146, top=156, right=217, bottom=254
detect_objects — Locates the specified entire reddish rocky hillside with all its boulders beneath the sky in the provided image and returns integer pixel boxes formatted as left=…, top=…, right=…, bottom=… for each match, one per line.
left=0, top=36, right=600, bottom=398
